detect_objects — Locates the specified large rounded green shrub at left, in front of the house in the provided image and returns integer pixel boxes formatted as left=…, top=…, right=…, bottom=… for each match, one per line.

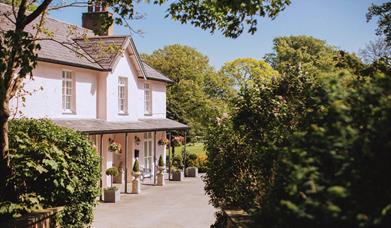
left=5, top=119, right=100, bottom=227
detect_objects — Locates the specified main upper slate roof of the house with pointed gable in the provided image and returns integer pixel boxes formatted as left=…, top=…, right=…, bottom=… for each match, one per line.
left=0, top=3, right=171, bottom=82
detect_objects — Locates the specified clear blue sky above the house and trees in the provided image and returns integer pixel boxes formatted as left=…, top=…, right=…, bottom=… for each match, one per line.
left=51, top=0, right=386, bottom=68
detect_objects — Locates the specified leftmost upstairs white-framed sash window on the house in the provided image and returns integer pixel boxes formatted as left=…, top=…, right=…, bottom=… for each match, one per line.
left=61, top=70, right=76, bottom=113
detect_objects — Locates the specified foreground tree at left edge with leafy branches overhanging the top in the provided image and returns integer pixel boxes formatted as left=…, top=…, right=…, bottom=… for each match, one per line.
left=0, top=0, right=290, bottom=203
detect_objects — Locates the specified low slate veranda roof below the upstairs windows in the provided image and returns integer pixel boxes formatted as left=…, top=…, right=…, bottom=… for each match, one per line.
left=53, top=119, right=189, bottom=134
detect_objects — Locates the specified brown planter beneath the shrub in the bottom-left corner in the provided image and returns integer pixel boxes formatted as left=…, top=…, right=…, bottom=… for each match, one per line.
left=0, top=207, right=63, bottom=228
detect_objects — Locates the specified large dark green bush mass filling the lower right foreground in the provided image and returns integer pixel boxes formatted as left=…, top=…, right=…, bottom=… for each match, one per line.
left=205, top=57, right=391, bottom=227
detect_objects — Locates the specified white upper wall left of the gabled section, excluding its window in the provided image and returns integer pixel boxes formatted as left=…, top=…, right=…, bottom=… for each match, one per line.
left=11, top=62, right=98, bottom=119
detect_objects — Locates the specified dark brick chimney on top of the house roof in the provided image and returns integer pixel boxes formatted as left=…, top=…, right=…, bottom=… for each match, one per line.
left=82, top=1, right=114, bottom=36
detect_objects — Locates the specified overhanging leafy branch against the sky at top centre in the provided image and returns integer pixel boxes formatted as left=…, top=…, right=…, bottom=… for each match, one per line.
left=159, top=0, right=291, bottom=38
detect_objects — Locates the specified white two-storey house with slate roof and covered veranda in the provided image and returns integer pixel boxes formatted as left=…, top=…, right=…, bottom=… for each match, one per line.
left=0, top=1, right=188, bottom=192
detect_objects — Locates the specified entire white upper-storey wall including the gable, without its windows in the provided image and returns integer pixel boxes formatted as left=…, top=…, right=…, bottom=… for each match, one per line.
left=11, top=52, right=166, bottom=121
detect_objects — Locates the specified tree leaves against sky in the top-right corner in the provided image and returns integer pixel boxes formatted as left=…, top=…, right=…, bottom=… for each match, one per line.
left=367, top=2, right=391, bottom=47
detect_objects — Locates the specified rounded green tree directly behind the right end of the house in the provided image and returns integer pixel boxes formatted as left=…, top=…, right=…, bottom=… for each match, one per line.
left=142, top=45, right=231, bottom=137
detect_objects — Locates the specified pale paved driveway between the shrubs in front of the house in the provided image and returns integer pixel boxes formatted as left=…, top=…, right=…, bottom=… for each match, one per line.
left=92, top=177, right=216, bottom=228
